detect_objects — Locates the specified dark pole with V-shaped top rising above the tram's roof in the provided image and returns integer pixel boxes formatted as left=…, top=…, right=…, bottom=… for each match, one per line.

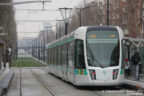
left=59, top=8, right=72, bottom=35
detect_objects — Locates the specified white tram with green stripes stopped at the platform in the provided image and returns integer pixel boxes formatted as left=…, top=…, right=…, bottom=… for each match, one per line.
left=47, top=26, right=124, bottom=86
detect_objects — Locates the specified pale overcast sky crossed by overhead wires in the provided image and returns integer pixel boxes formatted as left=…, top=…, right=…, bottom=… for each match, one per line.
left=13, top=0, right=81, bottom=37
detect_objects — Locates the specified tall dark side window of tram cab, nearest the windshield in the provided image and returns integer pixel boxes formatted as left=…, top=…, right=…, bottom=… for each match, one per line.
left=75, top=40, right=85, bottom=68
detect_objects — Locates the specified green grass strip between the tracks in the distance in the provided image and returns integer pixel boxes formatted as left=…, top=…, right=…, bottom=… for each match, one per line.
left=11, top=57, right=46, bottom=67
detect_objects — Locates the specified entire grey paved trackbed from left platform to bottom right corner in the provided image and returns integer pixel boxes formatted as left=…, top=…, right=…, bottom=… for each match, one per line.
left=0, top=68, right=144, bottom=96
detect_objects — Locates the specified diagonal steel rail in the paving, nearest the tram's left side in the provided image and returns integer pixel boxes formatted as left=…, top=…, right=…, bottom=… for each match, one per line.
left=30, top=69, right=57, bottom=96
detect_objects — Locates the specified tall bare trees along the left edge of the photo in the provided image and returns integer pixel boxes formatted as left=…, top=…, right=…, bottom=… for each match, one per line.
left=0, top=0, right=17, bottom=63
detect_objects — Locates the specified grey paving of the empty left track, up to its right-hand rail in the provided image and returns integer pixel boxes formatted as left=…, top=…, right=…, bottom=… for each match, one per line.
left=7, top=68, right=51, bottom=96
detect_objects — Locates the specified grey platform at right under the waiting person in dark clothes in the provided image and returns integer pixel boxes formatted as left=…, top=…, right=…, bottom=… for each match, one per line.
left=123, top=76, right=144, bottom=89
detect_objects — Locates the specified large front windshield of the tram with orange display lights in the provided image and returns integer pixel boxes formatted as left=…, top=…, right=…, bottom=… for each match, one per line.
left=86, top=30, right=120, bottom=68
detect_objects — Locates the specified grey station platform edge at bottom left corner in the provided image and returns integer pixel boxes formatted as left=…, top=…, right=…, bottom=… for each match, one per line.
left=0, top=69, right=14, bottom=96
